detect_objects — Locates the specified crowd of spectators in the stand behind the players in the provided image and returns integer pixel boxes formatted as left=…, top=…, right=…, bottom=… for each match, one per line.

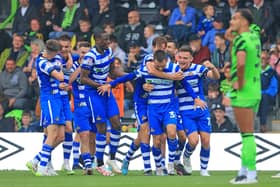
left=0, top=0, right=280, bottom=132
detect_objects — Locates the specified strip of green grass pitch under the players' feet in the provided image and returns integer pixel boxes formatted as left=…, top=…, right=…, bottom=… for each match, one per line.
left=0, top=171, right=280, bottom=187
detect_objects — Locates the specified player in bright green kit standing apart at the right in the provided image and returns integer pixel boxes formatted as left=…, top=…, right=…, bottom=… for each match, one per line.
left=230, top=9, right=261, bottom=184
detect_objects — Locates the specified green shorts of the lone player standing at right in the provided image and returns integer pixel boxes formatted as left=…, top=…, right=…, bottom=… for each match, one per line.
left=231, top=98, right=260, bottom=112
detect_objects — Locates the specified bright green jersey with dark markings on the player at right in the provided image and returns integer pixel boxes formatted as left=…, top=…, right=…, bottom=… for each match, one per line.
left=230, top=32, right=261, bottom=100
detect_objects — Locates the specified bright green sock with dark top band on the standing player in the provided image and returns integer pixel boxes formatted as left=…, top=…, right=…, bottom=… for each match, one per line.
left=241, top=133, right=257, bottom=171
